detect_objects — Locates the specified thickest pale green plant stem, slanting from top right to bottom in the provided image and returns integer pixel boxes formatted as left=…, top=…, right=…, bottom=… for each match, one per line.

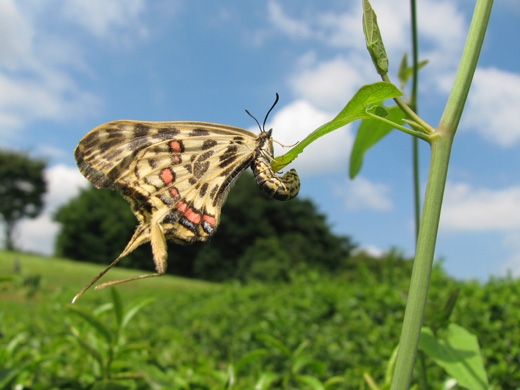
left=391, top=0, right=493, bottom=390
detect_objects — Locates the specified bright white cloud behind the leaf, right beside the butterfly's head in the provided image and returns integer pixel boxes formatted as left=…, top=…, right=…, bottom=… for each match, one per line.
left=267, top=100, right=352, bottom=174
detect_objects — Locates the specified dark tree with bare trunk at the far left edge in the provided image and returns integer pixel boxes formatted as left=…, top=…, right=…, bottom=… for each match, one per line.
left=0, top=150, right=47, bottom=250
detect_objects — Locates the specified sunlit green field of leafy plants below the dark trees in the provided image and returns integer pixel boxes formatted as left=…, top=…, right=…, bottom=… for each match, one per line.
left=0, top=252, right=520, bottom=390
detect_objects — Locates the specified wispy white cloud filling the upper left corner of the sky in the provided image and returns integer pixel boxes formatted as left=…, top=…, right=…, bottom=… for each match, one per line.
left=0, top=0, right=147, bottom=138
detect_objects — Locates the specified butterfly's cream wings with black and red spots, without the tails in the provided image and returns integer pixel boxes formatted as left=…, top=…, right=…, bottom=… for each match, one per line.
left=76, top=121, right=257, bottom=242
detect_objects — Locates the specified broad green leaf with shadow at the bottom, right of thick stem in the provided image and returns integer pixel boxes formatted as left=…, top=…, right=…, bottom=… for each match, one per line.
left=419, top=324, right=489, bottom=390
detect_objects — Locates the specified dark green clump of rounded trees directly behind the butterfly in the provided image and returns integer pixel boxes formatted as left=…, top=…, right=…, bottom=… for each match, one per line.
left=55, top=174, right=353, bottom=281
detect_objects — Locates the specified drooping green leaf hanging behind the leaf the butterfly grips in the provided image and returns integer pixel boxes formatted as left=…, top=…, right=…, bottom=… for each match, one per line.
left=349, top=106, right=405, bottom=179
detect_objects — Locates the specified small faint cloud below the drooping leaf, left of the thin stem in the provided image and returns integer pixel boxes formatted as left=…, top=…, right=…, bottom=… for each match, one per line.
left=334, top=176, right=394, bottom=211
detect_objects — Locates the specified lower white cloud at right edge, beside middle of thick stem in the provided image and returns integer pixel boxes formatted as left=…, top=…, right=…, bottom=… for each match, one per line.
left=441, top=183, right=520, bottom=232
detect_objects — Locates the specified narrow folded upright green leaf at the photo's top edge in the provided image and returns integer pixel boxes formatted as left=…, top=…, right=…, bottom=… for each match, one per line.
left=363, top=0, right=388, bottom=75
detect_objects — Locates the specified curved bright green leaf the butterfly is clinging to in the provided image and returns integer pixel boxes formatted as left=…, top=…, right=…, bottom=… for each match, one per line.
left=271, top=81, right=402, bottom=172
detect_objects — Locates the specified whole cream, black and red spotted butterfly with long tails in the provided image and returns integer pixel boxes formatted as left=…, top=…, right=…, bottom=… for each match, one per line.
left=72, top=94, right=300, bottom=303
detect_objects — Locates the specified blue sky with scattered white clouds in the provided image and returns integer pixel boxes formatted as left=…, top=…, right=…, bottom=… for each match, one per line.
left=0, top=0, right=520, bottom=281
